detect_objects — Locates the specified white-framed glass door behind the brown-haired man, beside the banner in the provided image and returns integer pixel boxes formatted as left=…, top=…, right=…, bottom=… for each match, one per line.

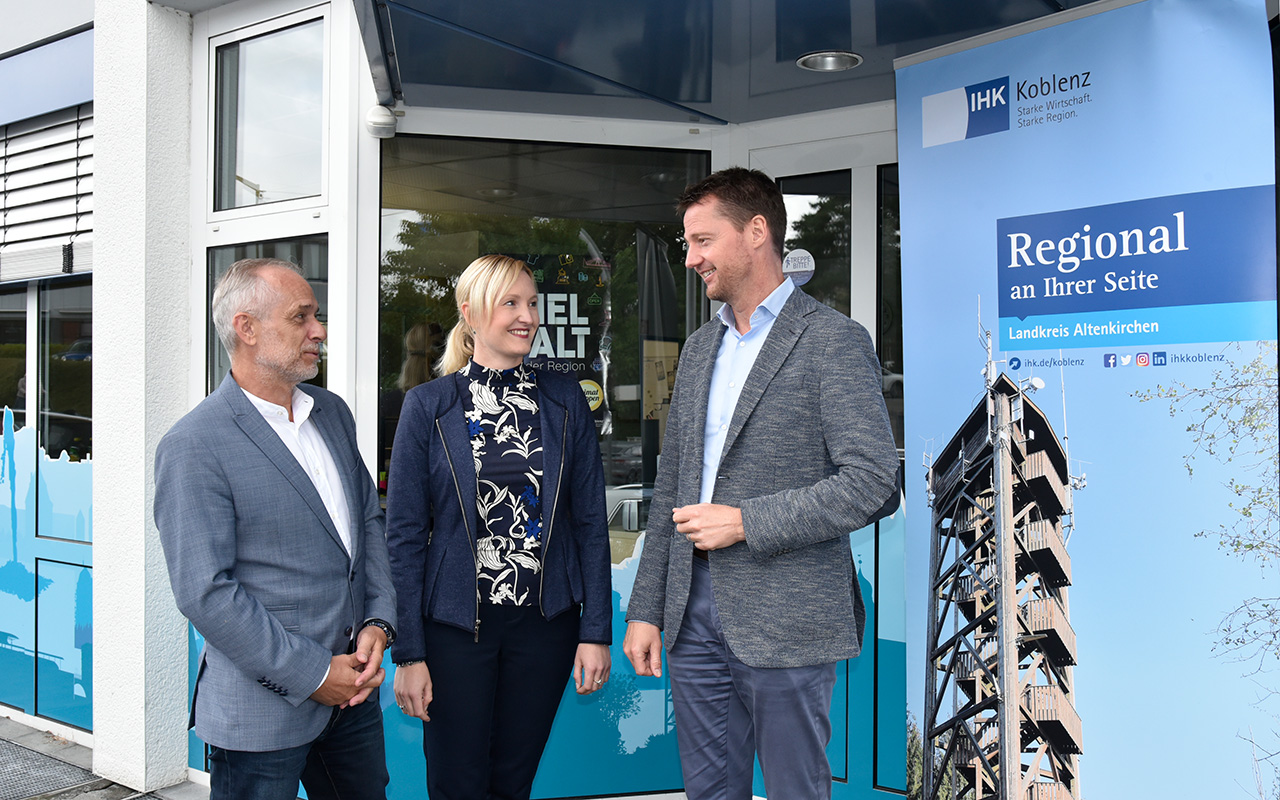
left=751, top=124, right=908, bottom=800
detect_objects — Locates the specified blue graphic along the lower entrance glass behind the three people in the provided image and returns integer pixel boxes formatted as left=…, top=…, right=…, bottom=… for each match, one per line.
left=188, top=509, right=906, bottom=800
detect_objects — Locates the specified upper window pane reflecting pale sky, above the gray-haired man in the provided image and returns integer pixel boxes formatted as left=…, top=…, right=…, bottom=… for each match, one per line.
left=214, top=19, right=324, bottom=211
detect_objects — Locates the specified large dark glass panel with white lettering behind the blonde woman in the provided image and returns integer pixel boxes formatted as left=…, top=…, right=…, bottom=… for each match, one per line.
left=378, top=134, right=710, bottom=797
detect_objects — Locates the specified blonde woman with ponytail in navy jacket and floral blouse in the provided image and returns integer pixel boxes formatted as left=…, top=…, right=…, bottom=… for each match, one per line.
left=387, top=256, right=612, bottom=800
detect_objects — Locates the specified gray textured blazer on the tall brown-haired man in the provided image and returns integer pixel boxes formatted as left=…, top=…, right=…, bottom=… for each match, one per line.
left=627, top=289, right=899, bottom=667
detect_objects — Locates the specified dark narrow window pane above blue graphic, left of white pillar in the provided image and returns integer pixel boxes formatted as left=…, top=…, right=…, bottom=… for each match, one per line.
left=38, top=282, right=93, bottom=461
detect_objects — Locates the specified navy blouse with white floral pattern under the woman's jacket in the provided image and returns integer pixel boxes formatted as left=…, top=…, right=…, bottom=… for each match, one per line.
left=457, top=361, right=543, bottom=605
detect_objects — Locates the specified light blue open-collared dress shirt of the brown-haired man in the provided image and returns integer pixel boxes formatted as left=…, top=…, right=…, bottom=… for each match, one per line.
left=699, top=278, right=796, bottom=503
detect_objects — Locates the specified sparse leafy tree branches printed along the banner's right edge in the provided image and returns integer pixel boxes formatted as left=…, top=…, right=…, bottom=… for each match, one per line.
left=1135, top=342, right=1280, bottom=671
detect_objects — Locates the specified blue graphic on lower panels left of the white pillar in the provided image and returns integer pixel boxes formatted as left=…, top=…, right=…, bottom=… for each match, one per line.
left=0, top=408, right=93, bottom=730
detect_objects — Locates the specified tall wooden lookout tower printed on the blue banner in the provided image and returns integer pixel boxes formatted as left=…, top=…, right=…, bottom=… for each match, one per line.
left=923, top=365, right=1083, bottom=800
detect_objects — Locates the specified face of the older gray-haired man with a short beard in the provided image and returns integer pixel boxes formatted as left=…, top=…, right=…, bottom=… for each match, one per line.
left=252, top=268, right=328, bottom=389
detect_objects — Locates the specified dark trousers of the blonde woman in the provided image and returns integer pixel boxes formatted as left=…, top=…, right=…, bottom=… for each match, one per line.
left=422, top=603, right=580, bottom=800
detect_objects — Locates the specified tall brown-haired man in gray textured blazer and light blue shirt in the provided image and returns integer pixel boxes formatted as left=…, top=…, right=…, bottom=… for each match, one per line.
left=623, top=168, right=899, bottom=800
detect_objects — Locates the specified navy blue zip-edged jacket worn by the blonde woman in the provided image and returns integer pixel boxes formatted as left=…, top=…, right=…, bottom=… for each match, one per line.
left=387, top=370, right=613, bottom=663
